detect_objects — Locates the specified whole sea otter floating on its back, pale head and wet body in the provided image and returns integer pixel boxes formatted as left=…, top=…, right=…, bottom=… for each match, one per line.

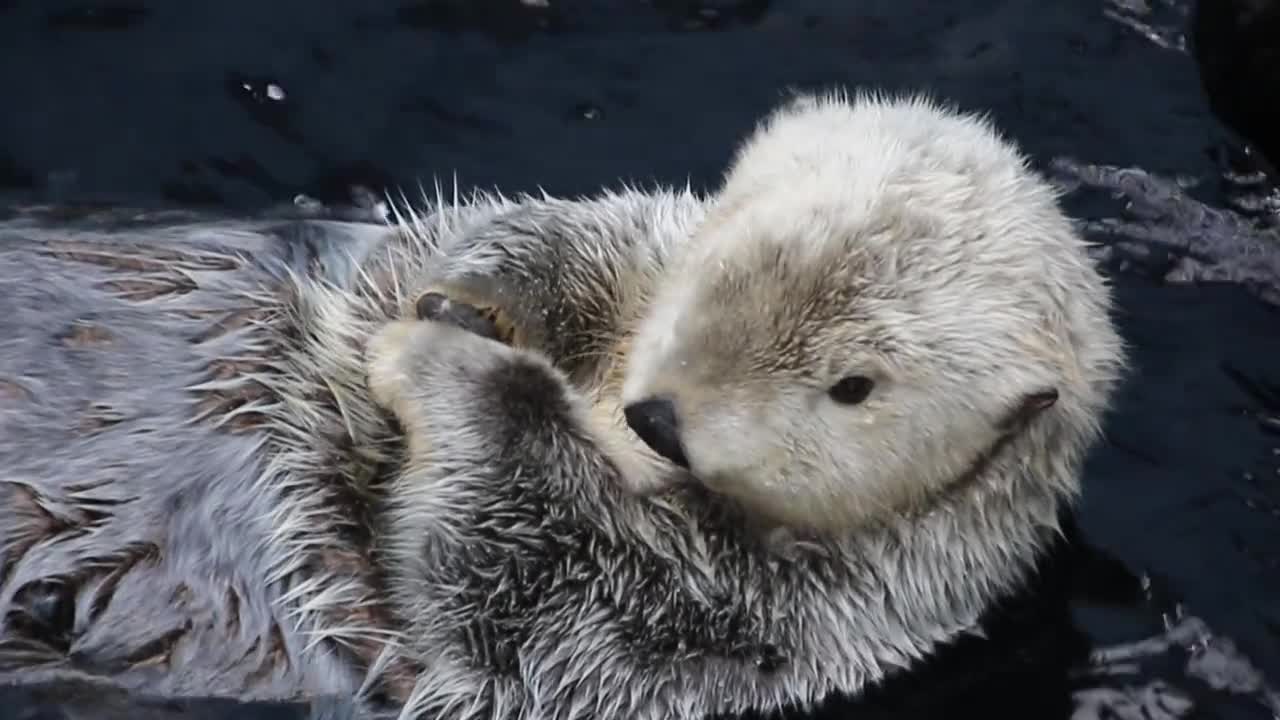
left=0, top=90, right=1120, bottom=720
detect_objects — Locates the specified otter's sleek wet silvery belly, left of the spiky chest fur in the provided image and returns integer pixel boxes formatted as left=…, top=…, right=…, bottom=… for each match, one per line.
left=0, top=210, right=385, bottom=698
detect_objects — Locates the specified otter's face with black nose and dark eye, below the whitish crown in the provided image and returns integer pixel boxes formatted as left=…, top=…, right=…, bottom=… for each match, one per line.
left=622, top=208, right=1090, bottom=528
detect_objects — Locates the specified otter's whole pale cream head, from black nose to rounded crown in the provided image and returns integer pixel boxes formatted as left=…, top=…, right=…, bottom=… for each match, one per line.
left=622, top=90, right=1120, bottom=530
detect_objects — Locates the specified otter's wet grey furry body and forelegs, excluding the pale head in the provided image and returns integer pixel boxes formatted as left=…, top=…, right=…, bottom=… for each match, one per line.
left=0, top=92, right=1126, bottom=720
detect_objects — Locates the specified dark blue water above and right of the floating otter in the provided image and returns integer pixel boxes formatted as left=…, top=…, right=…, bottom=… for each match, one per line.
left=0, top=0, right=1280, bottom=719
